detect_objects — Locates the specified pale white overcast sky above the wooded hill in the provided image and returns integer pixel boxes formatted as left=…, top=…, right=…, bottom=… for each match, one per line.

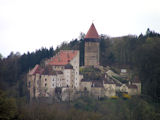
left=0, top=0, right=160, bottom=56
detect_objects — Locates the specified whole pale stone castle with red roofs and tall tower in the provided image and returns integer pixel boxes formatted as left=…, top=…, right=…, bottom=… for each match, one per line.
left=27, top=23, right=141, bottom=101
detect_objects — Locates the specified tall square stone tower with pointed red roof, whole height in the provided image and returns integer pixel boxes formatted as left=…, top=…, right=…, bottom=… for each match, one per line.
left=84, top=23, right=99, bottom=66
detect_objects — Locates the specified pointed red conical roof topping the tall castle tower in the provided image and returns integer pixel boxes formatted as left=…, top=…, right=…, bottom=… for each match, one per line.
left=85, top=23, right=99, bottom=39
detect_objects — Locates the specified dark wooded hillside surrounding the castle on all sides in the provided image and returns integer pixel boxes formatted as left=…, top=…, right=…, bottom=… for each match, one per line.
left=0, top=29, right=160, bottom=120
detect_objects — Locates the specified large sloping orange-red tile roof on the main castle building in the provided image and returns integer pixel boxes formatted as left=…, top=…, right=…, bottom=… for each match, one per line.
left=48, top=50, right=78, bottom=66
